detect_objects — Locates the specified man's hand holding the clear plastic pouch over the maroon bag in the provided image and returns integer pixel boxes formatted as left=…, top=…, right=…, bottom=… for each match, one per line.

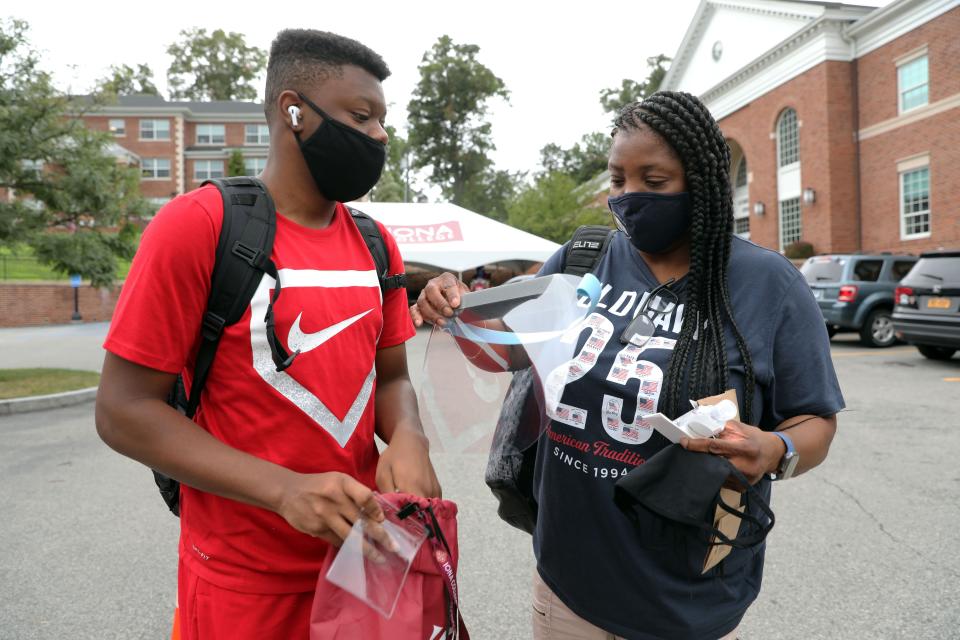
left=276, top=472, right=383, bottom=547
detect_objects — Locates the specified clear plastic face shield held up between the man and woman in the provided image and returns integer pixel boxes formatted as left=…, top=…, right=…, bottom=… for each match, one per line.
left=419, top=274, right=600, bottom=453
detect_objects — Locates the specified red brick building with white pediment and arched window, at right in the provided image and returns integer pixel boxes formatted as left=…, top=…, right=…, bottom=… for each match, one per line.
left=662, top=0, right=960, bottom=253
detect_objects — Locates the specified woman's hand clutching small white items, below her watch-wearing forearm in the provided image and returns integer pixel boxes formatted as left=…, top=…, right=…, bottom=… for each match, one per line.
left=680, top=420, right=786, bottom=491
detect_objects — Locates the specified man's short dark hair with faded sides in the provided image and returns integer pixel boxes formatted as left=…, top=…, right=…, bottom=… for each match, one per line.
left=264, top=29, right=390, bottom=120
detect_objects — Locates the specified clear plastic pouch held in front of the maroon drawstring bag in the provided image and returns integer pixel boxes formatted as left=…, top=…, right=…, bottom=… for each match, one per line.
left=326, top=495, right=427, bottom=618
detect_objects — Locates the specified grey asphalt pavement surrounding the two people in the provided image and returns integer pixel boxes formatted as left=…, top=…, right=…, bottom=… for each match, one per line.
left=0, top=325, right=960, bottom=640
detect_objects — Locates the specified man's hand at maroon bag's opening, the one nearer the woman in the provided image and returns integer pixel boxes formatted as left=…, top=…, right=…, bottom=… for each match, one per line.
left=377, top=429, right=440, bottom=498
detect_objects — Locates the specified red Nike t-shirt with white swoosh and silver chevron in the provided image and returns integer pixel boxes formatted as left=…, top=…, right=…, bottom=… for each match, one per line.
left=104, top=185, right=415, bottom=593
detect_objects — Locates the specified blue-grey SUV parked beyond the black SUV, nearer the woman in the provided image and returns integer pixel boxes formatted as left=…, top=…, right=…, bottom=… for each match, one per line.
left=800, top=253, right=917, bottom=347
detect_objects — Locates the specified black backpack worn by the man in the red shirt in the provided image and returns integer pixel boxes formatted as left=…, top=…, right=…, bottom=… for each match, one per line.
left=153, top=177, right=406, bottom=516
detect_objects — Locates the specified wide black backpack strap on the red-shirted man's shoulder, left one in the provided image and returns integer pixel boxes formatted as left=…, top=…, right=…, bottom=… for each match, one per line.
left=186, top=177, right=280, bottom=418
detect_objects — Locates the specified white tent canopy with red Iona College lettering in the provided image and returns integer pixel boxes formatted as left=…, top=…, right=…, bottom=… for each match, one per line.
left=350, top=202, right=560, bottom=272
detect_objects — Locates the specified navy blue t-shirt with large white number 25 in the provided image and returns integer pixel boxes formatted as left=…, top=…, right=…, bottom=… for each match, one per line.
left=533, top=233, right=844, bottom=640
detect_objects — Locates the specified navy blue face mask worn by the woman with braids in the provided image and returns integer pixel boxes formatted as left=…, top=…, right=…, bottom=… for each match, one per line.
left=607, top=191, right=693, bottom=253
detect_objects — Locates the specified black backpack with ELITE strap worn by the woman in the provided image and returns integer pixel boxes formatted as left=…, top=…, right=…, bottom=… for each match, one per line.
left=484, top=225, right=616, bottom=533
